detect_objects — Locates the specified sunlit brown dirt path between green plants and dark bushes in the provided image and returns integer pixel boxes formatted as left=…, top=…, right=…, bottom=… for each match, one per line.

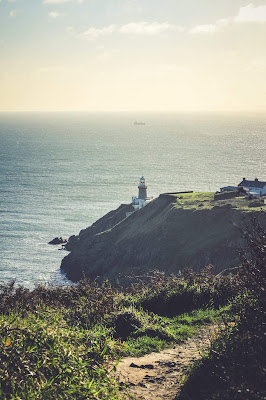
left=112, top=325, right=217, bottom=400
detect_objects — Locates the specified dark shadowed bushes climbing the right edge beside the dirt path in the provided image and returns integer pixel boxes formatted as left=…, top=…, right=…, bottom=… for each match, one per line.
left=177, top=218, right=266, bottom=400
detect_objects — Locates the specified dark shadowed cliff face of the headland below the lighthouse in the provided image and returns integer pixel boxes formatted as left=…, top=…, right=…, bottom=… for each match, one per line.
left=61, top=195, right=265, bottom=281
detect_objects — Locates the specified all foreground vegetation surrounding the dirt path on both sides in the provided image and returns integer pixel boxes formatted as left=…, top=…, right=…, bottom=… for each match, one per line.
left=0, top=214, right=266, bottom=400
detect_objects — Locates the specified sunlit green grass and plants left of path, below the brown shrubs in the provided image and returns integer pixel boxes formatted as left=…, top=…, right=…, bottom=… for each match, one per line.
left=0, top=298, right=230, bottom=400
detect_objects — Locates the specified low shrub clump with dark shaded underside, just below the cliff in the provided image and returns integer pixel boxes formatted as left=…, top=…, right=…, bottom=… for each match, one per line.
left=124, top=266, right=239, bottom=317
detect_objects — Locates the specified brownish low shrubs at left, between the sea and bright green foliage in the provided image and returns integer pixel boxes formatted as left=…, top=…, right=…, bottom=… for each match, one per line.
left=0, top=279, right=116, bottom=327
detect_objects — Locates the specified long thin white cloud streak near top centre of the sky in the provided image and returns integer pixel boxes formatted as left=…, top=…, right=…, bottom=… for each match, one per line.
left=80, top=21, right=183, bottom=40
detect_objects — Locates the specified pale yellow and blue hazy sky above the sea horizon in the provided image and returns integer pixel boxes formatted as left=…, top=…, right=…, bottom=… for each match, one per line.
left=0, top=0, right=266, bottom=112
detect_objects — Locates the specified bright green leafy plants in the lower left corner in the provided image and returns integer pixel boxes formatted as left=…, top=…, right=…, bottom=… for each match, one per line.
left=0, top=309, right=119, bottom=399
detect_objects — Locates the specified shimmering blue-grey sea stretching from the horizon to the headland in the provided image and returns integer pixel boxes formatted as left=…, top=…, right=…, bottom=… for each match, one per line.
left=0, top=113, right=266, bottom=288
